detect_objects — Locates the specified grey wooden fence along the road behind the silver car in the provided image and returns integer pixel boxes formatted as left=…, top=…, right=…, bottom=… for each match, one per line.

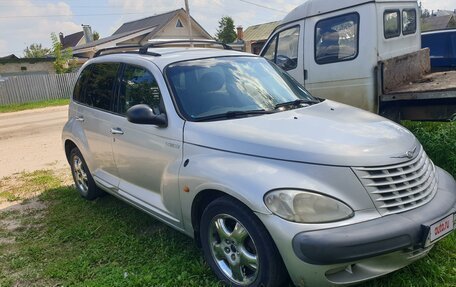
left=0, top=73, right=77, bottom=105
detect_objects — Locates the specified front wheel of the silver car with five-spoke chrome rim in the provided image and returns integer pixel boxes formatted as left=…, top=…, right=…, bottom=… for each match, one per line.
left=200, top=197, right=288, bottom=287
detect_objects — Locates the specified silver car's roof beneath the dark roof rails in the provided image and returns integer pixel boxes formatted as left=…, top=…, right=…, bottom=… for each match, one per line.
left=87, top=47, right=258, bottom=71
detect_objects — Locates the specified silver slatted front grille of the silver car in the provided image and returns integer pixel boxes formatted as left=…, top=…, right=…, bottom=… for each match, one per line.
left=353, top=148, right=437, bottom=215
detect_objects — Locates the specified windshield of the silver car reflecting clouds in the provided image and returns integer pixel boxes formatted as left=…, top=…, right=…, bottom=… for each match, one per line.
left=166, top=57, right=318, bottom=121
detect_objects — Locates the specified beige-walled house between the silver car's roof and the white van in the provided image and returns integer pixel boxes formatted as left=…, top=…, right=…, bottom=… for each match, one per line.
left=238, top=21, right=280, bottom=55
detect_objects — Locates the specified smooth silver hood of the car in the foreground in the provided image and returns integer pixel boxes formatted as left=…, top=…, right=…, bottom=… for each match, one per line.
left=184, top=100, right=419, bottom=166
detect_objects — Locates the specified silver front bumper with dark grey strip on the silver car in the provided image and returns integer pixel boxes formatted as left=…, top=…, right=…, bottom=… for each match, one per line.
left=259, top=168, right=456, bottom=286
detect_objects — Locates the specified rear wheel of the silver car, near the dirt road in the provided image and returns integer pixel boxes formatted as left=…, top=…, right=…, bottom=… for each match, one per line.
left=70, top=148, right=104, bottom=200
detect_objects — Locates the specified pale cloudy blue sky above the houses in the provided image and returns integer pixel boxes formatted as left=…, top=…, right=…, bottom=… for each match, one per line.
left=0, top=0, right=456, bottom=57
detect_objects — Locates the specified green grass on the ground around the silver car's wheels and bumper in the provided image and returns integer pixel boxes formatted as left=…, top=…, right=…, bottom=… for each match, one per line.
left=0, top=122, right=456, bottom=287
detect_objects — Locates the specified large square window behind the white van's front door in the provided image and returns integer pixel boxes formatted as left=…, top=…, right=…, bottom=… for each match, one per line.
left=315, top=13, right=359, bottom=65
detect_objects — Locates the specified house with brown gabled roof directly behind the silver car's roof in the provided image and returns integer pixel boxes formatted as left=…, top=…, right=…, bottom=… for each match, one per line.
left=73, top=8, right=213, bottom=58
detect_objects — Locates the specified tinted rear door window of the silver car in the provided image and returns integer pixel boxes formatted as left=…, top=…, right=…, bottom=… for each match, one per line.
left=84, top=63, right=120, bottom=111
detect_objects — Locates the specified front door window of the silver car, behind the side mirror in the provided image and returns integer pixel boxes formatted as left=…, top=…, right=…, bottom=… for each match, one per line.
left=119, top=65, right=161, bottom=115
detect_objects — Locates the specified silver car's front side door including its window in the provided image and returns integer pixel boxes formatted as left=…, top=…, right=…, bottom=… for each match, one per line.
left=112, top=62, right=183, bottom=227
